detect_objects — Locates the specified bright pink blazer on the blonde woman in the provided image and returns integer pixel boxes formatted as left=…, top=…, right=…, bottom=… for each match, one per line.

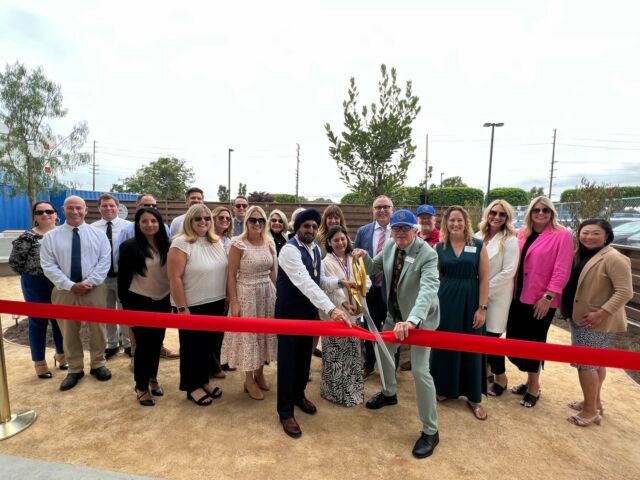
left=514, top=225, right=573, bottom=308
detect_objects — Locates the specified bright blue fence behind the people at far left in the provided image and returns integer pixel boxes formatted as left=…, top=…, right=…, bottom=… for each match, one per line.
left=0, top=185, right=138, bottom=232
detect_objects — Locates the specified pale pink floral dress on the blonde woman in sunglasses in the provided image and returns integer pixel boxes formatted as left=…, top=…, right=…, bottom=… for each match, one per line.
left=222, top=237, right=278, bottom=372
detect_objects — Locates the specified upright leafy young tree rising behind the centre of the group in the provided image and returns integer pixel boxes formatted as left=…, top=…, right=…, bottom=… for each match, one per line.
left=325, top=64, right=420, bottom=203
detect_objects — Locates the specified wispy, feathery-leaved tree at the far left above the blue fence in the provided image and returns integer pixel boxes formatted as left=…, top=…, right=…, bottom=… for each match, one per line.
left=0, top=62, right=91, bottom=204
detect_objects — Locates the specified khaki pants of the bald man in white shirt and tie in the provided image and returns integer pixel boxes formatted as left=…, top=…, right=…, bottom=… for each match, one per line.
left=51, top=285, right=107, bottom=373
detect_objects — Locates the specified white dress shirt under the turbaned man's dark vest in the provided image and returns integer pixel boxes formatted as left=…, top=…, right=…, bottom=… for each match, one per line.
left=278, top=243, right=340, bottom=314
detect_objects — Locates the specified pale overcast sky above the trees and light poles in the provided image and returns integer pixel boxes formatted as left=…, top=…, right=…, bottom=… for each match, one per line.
left=0, top=0, right=640, bottom=200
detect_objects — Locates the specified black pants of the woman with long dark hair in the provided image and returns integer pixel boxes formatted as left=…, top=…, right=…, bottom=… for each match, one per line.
left=123, top=292, right=171, bottom=391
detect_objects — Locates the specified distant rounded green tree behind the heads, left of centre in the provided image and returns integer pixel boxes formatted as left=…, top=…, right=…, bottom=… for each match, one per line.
left=111, top=157, right=195, bottom=200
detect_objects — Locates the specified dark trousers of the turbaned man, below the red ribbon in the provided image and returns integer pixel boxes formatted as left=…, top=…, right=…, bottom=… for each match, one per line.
left=278, top=335, right=313, bottom=419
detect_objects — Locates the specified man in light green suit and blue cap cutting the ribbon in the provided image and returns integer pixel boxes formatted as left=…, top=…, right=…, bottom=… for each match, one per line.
left=353, top=210, right=440, bottom=458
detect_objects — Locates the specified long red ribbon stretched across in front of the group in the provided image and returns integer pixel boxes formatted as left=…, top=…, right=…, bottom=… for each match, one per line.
left=0, top=300, right=640, bottom=370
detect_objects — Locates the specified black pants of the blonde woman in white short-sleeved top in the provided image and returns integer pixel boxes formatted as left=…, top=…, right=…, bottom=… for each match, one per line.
left=178, top=299, right=224, bottom=392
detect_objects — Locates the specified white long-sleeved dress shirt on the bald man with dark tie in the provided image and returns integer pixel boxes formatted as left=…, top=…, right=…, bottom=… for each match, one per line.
left=40, top=223, right=111, bottom=290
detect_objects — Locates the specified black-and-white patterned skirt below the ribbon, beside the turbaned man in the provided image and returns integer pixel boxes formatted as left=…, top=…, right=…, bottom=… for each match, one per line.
left=320, top=337, right=364, bottom=407
